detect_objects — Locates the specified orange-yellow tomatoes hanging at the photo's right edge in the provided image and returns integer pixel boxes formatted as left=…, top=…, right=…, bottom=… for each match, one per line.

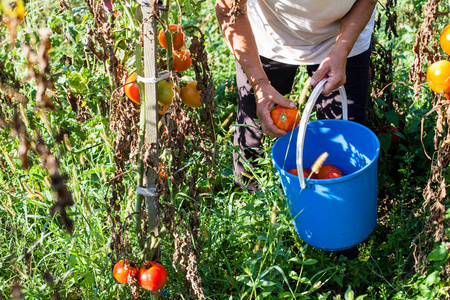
left=427, top=25, right=450, bottom=99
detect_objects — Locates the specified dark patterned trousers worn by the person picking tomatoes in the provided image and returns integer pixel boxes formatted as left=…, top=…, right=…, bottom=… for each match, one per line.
left=233, top=50, right=370, bottom=191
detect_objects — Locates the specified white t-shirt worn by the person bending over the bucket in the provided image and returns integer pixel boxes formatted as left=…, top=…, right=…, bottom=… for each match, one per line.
left=247, top=0, right=375, bottom=65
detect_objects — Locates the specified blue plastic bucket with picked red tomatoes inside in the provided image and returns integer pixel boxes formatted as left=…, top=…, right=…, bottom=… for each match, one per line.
left=271, top=79, right=380, bottom=251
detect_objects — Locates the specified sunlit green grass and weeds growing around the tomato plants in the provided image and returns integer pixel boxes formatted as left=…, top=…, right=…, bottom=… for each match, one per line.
left=0, top=0, right=449, bottom=300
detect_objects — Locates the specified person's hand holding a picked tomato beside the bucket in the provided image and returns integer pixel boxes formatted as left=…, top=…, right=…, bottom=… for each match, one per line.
left=253, top=83, right=297, bottom=137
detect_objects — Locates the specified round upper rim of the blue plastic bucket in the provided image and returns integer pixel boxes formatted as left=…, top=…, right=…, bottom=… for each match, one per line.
left=270, top=119, right=380, bottom=186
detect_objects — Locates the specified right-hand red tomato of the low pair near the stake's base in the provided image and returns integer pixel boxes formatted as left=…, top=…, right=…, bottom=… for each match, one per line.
left=139, top=261, right=167, bottom=291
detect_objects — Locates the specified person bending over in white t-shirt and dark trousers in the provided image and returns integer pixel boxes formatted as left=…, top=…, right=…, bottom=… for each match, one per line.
left=216, top=0, right=377, bottom=191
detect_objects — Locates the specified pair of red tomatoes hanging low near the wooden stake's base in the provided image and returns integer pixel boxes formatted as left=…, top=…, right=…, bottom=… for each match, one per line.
left=113, top=260, right=167, bottom=291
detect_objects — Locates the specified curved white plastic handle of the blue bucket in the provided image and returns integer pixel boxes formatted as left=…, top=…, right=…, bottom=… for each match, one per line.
left=296, top=78, right=348, bottom=189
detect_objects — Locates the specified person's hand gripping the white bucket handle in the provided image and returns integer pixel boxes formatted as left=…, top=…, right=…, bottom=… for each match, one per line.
left=311, top=52, right=347, bottom=95
